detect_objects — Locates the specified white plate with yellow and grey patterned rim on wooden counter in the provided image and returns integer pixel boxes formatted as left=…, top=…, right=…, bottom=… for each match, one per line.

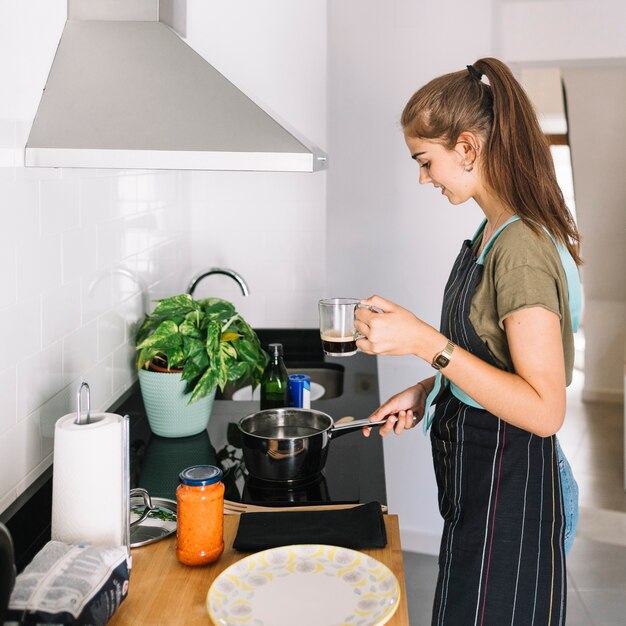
left=207, top=544, right=400, bottom=626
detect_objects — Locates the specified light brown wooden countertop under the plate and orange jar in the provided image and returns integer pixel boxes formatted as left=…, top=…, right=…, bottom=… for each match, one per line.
left=109, top=513, right=409, bottom=626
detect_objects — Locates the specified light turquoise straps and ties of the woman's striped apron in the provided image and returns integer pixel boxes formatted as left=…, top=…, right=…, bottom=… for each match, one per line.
left=422, top=215, right=582, bottom=434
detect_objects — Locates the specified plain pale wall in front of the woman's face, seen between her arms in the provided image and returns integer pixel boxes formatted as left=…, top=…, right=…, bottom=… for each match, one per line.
left=328, top=0, right=494, bottom=553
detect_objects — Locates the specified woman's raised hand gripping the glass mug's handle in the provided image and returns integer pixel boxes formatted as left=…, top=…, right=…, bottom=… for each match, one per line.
left=354, top=296, right=426, bottom=355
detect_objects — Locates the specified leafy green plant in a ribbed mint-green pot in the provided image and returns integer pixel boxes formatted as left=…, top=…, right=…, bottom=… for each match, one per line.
left=135, top=294, right=268, bottom=437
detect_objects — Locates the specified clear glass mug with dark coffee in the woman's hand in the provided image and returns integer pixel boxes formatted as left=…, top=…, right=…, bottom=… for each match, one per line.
left=318, top=298, right=382, bottom=356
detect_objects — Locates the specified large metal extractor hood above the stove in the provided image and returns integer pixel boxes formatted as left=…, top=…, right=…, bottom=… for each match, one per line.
left=25, top=0, right=326, bottom=172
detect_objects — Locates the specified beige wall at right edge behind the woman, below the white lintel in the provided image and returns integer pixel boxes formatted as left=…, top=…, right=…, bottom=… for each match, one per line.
left=563, top=64, right=626, bottom=402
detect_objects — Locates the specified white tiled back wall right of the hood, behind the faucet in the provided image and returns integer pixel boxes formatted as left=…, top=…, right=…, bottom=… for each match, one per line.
left=180, top=0, right=327, bottom=328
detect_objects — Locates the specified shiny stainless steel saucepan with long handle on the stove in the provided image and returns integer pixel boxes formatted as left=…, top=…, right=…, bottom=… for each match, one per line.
left=239, top=408, right=387, bottom=483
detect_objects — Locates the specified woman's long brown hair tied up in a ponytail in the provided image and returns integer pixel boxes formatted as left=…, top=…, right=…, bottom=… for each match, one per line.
left=400, top=58, right=582, bottom=265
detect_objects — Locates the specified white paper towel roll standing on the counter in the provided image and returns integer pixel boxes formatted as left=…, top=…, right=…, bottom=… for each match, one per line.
left=52, top=413, right=128, bottom=546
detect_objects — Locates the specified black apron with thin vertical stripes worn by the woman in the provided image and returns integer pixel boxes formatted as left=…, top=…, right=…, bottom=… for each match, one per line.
left=430, top=240, right=566, bottom=626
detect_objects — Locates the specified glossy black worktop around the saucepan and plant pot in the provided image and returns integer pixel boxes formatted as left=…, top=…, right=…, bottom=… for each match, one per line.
left=123, top=329, right=387, bottom=504
